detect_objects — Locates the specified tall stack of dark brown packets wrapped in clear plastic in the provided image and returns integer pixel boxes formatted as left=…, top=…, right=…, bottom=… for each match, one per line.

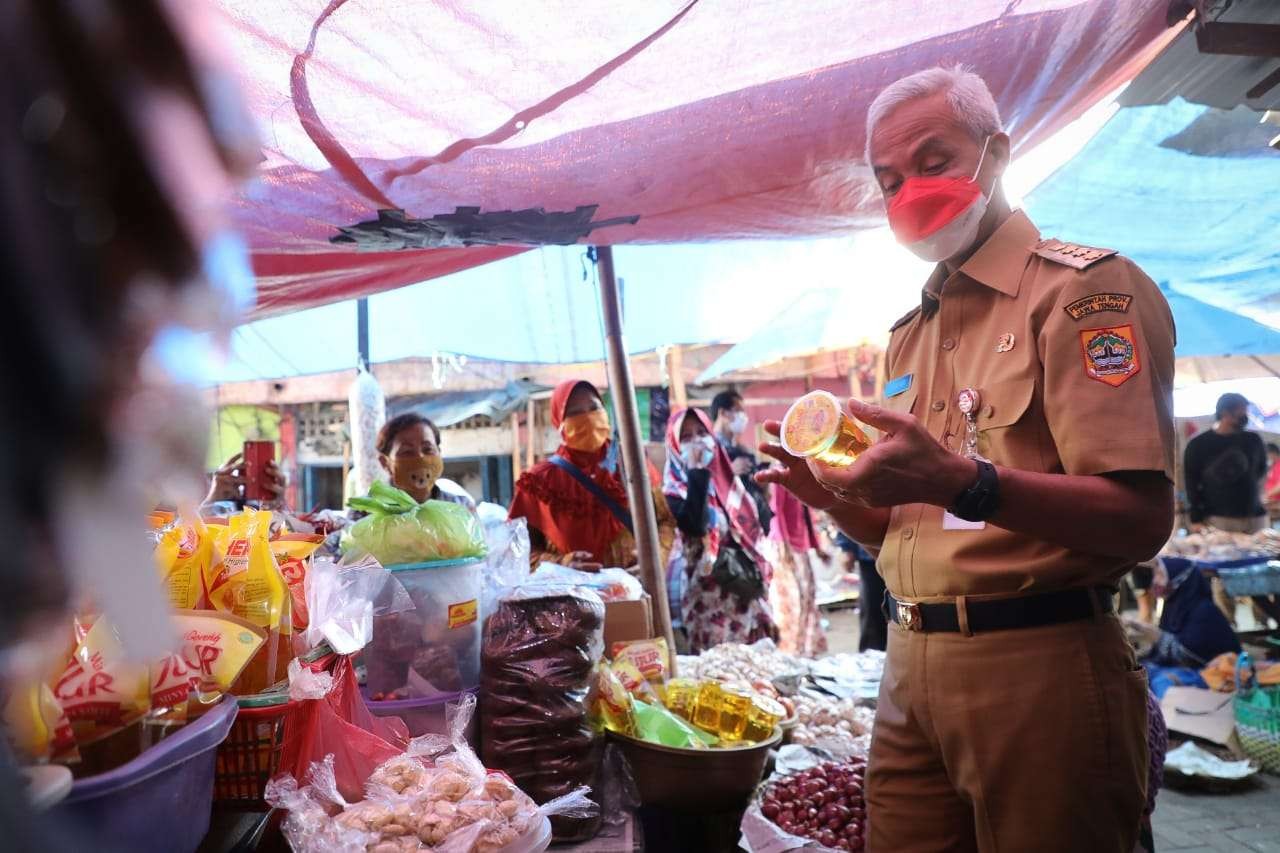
left=480, top=585, right=604, bottom=840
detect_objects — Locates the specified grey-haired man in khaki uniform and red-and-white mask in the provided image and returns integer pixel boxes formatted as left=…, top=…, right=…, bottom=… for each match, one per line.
left=760, top=68, right=1174, bottom=853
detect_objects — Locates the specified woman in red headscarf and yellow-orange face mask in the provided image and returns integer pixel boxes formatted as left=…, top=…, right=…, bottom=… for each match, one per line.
left=509, top=379, right=675, bottom=571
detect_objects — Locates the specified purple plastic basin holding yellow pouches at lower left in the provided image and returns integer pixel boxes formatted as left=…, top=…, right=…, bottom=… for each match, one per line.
left=51, top=699, right=237, bottom=853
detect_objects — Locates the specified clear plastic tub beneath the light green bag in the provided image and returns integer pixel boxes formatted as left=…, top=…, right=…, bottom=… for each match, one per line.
left=364, top=560, right=484, bottom=701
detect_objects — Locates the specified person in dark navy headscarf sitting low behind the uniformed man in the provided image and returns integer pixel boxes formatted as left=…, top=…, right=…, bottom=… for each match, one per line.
left=1126, top=560, right=1240, bottom=670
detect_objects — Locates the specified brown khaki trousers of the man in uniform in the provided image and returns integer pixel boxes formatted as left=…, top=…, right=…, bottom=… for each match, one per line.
left=867, top=607, right=1148, bottom=853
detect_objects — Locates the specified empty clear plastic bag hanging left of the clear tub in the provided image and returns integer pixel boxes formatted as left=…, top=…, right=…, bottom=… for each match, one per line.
left=303, top=555, right=413, bottom=654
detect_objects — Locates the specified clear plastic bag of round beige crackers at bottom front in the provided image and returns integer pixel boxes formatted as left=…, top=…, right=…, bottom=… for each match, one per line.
left=266, top=695, right=599, bottom=853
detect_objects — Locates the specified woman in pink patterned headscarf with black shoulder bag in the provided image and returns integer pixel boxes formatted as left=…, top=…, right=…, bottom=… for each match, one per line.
left=662, top=409, right=777, bottom=654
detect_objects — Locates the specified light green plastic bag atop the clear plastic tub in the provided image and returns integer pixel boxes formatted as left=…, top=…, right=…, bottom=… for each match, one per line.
left=342, top=482, right=485, bottom=566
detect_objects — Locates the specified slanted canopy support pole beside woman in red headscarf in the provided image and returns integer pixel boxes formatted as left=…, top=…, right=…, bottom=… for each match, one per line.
left=595, top=246, right=676, bottom=649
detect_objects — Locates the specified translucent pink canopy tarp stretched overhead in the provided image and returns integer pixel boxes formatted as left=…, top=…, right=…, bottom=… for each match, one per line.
left=218, top=0, right=1169, bottom=316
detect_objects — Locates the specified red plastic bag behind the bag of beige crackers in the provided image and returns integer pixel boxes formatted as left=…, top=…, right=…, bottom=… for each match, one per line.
left=280, top=654, right=408, bottom=803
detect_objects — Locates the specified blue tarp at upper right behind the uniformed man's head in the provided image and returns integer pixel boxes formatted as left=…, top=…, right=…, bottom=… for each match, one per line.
left=1027, top=99, right=1280, bottom=325
